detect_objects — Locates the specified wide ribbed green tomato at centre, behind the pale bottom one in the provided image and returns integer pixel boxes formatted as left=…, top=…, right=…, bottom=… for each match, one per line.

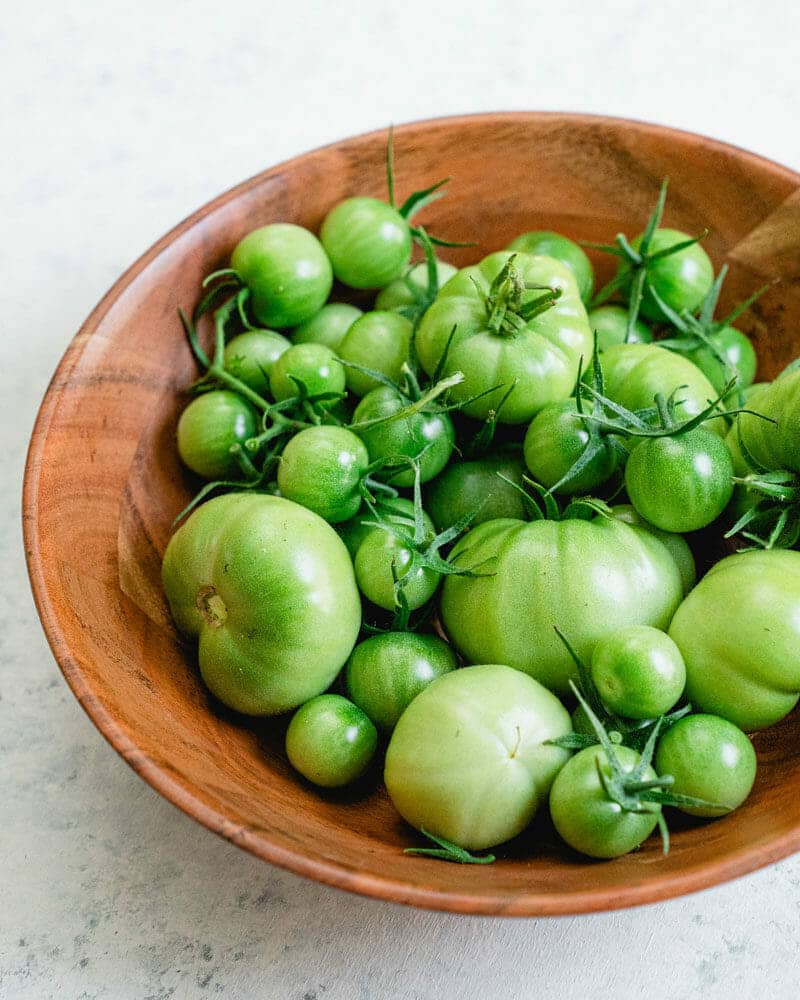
left=441, top=517, right=682, bottom=693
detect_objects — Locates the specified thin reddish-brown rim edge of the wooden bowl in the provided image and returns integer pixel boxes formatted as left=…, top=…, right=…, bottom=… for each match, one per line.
left=22, top=111, right=800, bottom=917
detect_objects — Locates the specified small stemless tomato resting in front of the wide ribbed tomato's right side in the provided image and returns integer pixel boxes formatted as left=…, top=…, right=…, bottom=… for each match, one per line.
left=591, top=625, right=686, bottom=719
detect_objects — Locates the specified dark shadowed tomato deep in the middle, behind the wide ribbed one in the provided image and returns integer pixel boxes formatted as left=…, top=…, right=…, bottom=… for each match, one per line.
left=425, top=453, right=525, bottom=531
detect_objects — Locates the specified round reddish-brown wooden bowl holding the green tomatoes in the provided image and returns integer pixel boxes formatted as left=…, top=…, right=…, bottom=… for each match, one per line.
left=23, top=114, right=800, bottom=915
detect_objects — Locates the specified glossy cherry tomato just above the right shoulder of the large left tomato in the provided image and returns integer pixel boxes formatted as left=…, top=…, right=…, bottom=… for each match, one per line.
left=278, top=426, right=369, bottom=524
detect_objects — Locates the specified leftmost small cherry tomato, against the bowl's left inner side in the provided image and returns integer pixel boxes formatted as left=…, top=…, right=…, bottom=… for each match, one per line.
left=178, top=389, right=258, bottom=479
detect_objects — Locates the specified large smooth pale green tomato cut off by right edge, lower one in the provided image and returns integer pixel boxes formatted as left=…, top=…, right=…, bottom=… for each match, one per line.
left=669, top=549, right=800, bottom=732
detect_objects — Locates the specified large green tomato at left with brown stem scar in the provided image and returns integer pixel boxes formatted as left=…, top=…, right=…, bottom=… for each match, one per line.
left=162, top=493, right=361, bottom=715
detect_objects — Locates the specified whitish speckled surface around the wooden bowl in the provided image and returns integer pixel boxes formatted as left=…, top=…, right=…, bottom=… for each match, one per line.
left=0, top=0, right=800, bottom=1000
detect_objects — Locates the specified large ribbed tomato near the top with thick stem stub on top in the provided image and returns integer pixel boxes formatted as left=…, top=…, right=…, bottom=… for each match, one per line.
left=415, top=251, right=592, bottom=424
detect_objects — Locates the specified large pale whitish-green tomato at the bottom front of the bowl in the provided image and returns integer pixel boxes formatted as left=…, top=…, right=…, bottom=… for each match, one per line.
left=384, top=665, right=572, bottom=850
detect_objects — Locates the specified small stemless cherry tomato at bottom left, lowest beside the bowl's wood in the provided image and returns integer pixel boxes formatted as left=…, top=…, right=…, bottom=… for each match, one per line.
left=286, top=694, right=378, bottom=788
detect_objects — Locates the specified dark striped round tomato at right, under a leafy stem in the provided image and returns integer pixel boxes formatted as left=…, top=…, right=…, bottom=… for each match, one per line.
left=625, top=427, right=733, bottom=532
